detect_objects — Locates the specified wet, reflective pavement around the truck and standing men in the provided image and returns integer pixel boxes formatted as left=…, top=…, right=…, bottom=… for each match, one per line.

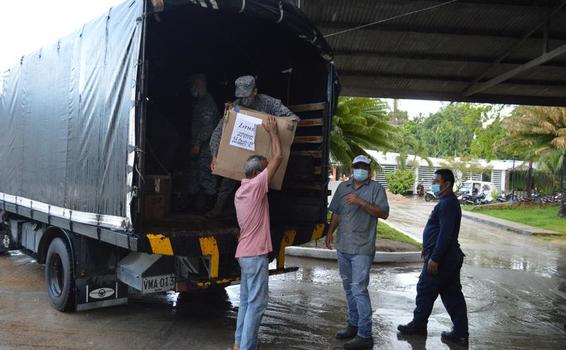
left=0, top=201, right=566, bottom=350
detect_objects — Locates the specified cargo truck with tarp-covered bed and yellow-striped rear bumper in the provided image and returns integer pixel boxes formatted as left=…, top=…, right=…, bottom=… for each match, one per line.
left=0, top=0, right=339, bottom=311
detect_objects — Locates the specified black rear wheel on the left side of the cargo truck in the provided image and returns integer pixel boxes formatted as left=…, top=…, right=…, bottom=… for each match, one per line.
left=45, top=238, right=74, bottom=311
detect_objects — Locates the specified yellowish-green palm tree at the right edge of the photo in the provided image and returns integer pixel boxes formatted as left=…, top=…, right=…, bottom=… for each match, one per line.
left=508, top=106, right=566, bottom=218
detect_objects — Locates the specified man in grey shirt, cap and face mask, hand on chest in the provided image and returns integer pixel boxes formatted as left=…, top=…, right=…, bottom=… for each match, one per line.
left=326, top=155, right=389, bottom=350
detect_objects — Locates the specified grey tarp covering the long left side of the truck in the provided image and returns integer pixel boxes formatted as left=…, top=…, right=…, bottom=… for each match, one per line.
left=0, top=0, right=144, bottom=226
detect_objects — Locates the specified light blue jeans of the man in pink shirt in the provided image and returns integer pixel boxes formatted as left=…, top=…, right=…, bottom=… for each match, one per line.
left=236, top=255, right=269, bottom=350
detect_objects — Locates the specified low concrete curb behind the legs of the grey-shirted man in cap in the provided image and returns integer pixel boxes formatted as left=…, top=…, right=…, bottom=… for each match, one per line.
left=285, top=247, right=422, bottom=263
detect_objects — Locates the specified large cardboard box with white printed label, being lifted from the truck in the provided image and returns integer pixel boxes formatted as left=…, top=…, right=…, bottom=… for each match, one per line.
left=213, top=105, right=299, bottom=190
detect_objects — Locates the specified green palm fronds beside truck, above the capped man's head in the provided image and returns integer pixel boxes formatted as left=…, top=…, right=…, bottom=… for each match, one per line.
left=330, top=97, right=397, bottom=170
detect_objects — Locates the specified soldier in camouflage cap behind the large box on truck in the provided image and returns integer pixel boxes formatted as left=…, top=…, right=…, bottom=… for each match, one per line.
left=206, top=75, right=298, bottom=218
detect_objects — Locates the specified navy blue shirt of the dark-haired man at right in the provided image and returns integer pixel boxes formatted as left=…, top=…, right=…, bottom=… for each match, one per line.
left=423, top=194, right=462, bottom=262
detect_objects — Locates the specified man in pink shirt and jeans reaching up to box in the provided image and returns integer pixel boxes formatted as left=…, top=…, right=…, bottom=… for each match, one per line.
left=234, top=116, right=283, bottom=350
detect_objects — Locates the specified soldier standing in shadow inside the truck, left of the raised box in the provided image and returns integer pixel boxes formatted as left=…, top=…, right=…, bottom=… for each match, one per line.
left=188, top=74, right=220, bottom=211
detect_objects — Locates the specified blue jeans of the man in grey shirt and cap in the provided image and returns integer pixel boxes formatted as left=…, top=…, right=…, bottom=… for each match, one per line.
left=337, top=252, right=373, bottom=338
